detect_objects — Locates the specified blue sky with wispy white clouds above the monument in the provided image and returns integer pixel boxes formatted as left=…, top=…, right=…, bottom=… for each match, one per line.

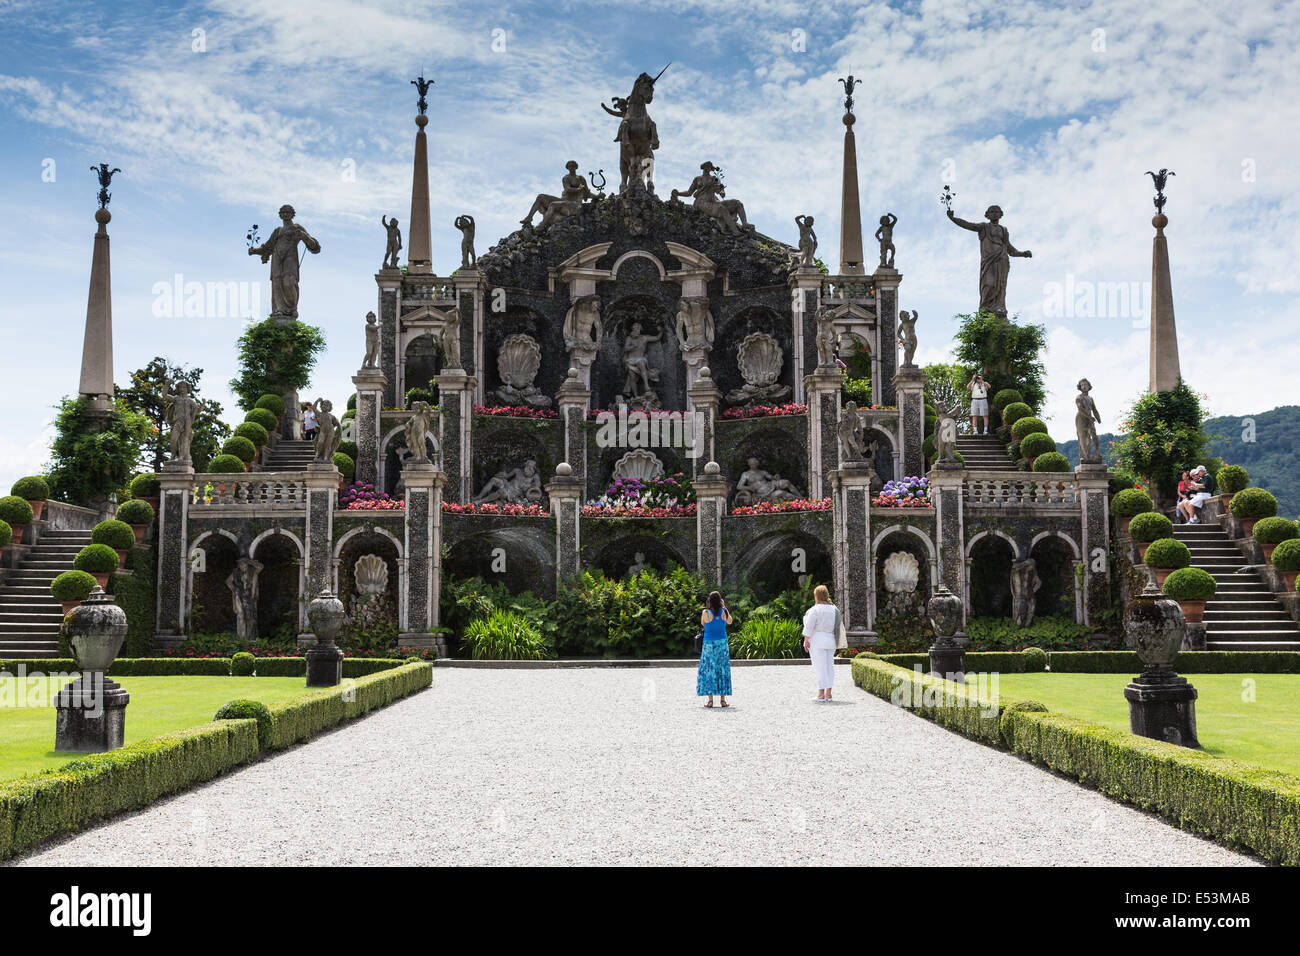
left=0, top=0, right=1300, bottom=490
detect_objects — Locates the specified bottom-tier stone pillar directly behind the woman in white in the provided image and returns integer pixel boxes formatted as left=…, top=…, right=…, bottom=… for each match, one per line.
left=831, top=462, right=876, bottom=648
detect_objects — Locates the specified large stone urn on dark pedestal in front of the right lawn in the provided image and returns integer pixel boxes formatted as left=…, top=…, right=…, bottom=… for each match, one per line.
left=1123, top=583, right=1200, bottom=748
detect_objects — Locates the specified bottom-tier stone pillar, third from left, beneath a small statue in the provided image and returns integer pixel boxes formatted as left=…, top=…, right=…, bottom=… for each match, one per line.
left=399, top=462, right=447, bottom=657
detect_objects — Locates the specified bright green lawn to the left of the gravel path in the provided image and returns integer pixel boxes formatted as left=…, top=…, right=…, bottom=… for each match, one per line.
left=0, top=676, right=307, bottom=780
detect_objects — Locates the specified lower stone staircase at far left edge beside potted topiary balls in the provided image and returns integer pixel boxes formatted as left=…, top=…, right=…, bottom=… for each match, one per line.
left=0, top=531, right=90, bottom=661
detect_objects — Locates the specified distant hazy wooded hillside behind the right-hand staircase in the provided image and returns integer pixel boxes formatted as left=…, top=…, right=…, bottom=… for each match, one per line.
left=1057, top=405, right=1300, bottom=518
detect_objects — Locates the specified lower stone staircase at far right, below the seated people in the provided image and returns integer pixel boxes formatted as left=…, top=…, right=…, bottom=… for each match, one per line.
left=1174, top=524, right=1300, bottom=650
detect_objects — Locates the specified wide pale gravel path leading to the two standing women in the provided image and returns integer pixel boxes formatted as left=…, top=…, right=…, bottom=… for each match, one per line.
left=10, top=666, right=1252, bottom=866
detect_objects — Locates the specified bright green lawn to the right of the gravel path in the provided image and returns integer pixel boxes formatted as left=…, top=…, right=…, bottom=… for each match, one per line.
left=998, top=674, right=1300, bottom=777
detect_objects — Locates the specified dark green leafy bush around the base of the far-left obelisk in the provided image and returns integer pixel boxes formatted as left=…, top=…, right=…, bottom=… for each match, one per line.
left=47, top=398, right=153, bottom=507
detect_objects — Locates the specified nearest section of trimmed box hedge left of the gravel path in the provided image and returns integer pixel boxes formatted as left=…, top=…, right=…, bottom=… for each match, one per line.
left=0, top=721, right=257, bottom=860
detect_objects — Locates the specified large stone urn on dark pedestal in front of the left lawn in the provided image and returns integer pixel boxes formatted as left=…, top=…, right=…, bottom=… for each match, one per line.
left=55, top=588, right=131, bottom=753
